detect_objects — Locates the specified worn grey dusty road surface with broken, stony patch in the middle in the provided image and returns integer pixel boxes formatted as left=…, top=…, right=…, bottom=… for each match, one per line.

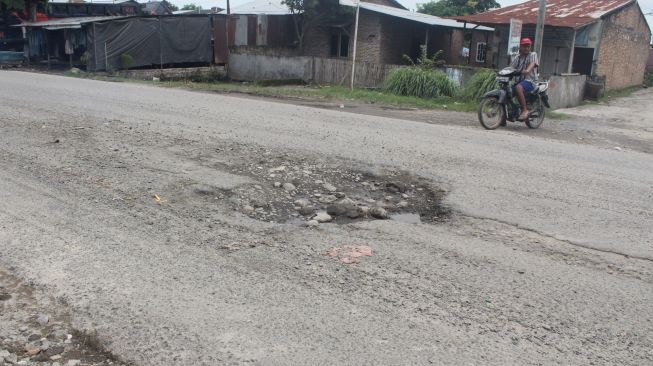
left=0, top=72, right=653, bottom=365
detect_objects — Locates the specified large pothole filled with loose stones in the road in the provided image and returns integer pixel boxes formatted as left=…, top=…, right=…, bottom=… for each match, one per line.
left=188, top=153, right=449, bottom=225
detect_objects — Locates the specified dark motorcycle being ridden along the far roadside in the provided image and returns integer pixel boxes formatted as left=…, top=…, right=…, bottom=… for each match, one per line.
left=478, top=67, right=551, bottom=130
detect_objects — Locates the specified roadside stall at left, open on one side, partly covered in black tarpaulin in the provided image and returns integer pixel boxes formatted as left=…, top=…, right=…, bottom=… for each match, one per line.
left=20, top=14, right=213, bottom=71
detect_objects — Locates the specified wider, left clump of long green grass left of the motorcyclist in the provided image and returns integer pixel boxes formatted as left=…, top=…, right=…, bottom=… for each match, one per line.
left=385, top=67, right=458, bottom=98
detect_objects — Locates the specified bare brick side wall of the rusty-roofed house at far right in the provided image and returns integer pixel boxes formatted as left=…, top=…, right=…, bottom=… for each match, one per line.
left=595, top=3, right=651, bottom=90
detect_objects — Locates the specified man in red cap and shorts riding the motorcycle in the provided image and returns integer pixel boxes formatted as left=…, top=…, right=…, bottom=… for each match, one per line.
left=510, top=38, right=539, bottom=121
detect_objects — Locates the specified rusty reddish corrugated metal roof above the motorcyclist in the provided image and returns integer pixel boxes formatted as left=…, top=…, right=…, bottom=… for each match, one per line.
left=455, top=0, right=636, bottom=28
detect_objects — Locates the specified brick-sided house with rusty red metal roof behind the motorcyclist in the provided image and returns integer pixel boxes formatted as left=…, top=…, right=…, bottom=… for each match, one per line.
left=457, top=0, right=651, bottom=90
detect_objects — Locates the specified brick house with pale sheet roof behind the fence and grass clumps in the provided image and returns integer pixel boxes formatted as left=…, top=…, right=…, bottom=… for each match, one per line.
left=304, top=0, right=493, bottom=66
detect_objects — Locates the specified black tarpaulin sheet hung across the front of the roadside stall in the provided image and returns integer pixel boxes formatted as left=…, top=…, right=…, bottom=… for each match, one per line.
left=88, top=16, right=212, bottom=71
